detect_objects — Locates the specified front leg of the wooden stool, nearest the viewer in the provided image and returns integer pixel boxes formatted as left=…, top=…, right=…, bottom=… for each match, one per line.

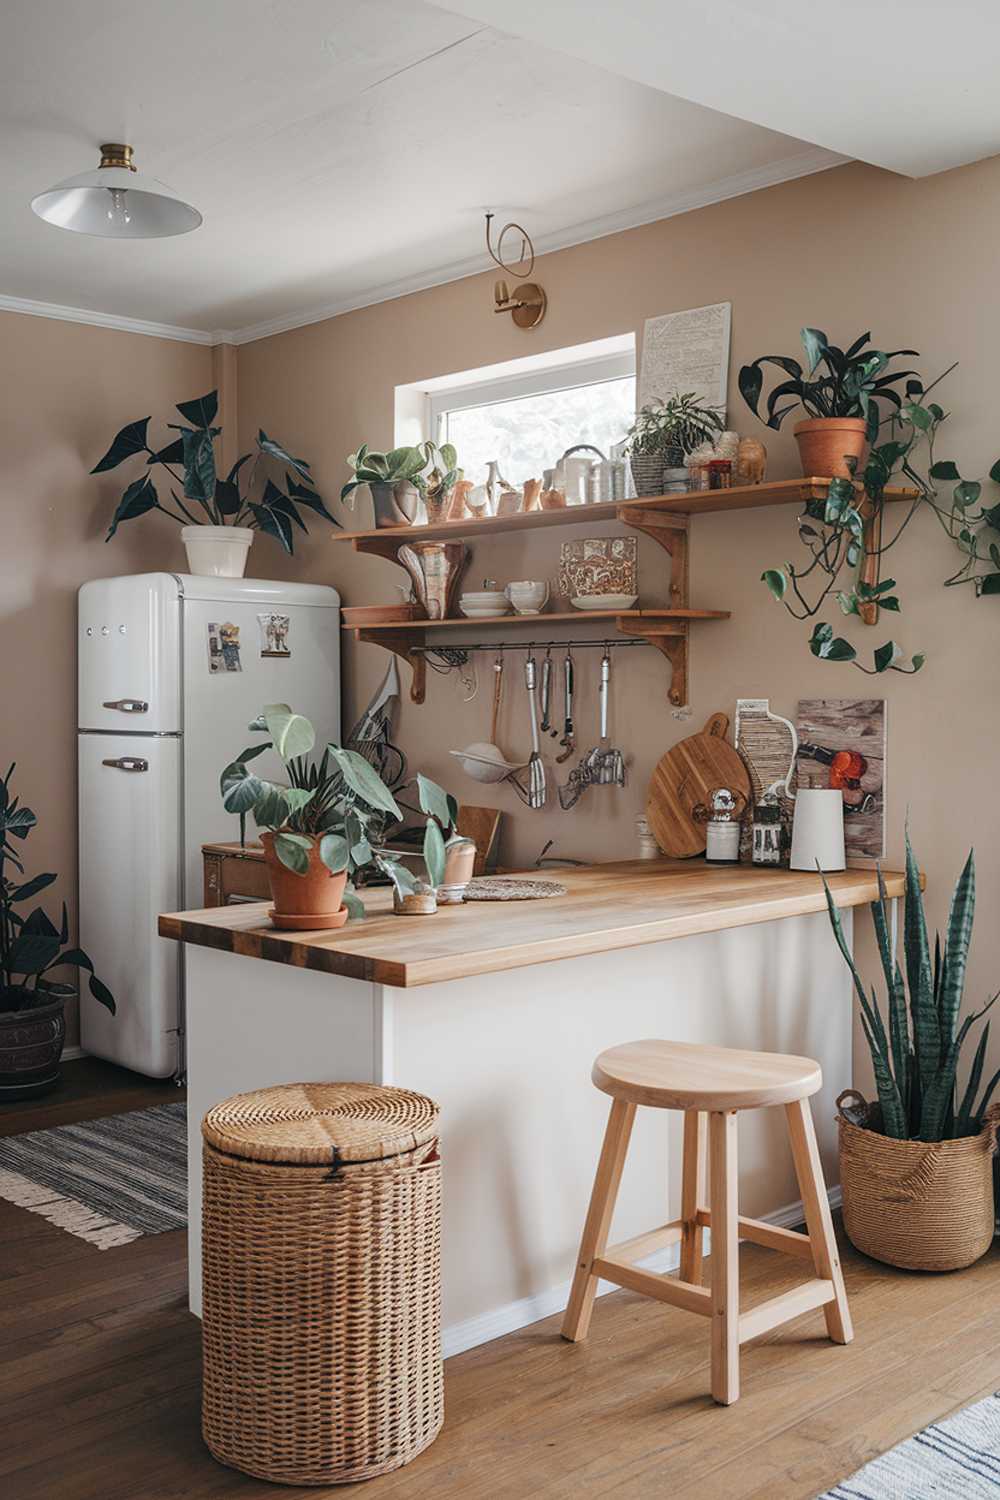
left=708, top=1110, right=739, bottom=1406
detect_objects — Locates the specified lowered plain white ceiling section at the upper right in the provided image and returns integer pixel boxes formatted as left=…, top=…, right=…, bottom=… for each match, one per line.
left=448, top=0, right=1000, bottom=177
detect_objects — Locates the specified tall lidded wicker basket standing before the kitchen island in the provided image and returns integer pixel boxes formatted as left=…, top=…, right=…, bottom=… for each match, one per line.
left=202, top=1083, right=444, bottom=1485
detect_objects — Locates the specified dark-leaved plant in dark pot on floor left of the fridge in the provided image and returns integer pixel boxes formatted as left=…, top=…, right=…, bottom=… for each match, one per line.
left=0, top=767, right=114, bottom=1103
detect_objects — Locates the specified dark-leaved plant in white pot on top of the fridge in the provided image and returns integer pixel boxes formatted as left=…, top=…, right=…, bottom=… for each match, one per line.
left=90, top=390, right=339, bottom=578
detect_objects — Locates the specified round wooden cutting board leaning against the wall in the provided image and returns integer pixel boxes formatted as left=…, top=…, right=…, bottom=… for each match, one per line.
left=646, top=714, right=751, bottom=860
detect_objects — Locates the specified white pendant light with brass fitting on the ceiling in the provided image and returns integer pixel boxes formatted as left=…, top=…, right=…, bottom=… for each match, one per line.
left=31, top=144, right=201, bottom=240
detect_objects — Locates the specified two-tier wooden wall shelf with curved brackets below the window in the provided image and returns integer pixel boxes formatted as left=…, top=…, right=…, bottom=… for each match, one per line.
left=333, top=479, right=916, bottom=707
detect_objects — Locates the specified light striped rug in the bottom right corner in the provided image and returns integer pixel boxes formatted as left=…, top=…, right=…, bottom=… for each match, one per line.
left=819, top=1391, right=1000, bottom=1500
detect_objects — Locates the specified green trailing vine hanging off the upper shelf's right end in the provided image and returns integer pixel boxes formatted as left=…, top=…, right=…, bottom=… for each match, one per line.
left=758, top=354, right=1000, bottom=675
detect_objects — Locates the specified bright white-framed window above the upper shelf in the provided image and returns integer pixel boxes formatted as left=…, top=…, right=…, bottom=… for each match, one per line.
left=407, top=335, right=636, bottom=485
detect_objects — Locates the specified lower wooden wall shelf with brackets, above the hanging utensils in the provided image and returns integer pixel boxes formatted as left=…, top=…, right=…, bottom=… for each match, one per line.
left=343, top=609, right=730, bottom=707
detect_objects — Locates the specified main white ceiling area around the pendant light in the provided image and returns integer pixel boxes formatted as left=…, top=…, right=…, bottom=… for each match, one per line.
left=0, top=0, right=838, bottom=339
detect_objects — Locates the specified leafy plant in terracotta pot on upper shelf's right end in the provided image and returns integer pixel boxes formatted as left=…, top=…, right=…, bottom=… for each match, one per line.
left=739, top=329, right=924, bottom=479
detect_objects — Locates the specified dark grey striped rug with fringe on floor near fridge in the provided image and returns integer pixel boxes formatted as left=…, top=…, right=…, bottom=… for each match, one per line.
left=0, top=1103, right=187, bottom=1250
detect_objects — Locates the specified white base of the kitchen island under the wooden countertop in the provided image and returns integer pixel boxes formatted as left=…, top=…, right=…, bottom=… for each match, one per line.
left=186, top=903, right=852, bottom=1355
